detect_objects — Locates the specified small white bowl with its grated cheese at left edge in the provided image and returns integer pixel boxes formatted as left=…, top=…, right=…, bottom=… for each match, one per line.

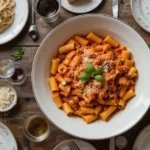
left=0, top=82, right=17, bottom=112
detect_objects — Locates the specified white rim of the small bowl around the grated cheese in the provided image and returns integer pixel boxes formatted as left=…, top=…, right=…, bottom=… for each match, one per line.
left=0, top=81, right=18, bottom=112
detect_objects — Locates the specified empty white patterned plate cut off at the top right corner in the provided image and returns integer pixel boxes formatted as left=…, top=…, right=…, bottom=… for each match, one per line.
left=130, top=0, right=150, bottom=32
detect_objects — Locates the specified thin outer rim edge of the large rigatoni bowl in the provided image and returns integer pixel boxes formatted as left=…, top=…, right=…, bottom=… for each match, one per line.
left=31, top=13, right=150, bottom=141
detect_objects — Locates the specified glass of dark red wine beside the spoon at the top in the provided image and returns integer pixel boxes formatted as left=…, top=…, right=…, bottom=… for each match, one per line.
left=33, top=0, right=61, bottom=22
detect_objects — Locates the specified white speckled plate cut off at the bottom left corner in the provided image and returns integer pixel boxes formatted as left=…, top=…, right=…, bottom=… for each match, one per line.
left=0, top=122, right=18, bottom=150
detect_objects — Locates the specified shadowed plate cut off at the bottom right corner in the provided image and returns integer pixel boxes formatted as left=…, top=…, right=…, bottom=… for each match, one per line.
left=133, top=124, right=150, bottom=150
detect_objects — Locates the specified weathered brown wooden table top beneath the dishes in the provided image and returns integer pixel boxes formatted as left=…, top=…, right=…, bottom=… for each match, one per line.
left=0, top=0, right=150, bottom=150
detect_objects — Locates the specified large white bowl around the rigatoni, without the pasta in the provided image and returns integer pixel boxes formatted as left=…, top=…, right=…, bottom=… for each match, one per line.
left=32, top=14, right=150, bottom=140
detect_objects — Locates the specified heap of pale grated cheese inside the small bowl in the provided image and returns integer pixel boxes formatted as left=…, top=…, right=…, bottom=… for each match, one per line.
left=0, top=86, right=14, bottom=109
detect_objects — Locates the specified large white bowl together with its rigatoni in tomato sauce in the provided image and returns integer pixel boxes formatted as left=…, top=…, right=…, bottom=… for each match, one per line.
left=32, top=14, right=150, bottom=140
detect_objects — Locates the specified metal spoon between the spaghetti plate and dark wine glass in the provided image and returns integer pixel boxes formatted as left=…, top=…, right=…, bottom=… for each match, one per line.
left=29, top=0, right=38, bottom=40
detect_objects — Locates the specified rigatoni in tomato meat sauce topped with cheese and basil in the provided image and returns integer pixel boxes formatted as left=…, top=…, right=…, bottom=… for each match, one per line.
left=49, top=32, right=138, bottom=123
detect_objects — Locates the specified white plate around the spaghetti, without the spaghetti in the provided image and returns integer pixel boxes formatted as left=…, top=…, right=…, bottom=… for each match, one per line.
left=0, top=0, right=29, bottom=45
